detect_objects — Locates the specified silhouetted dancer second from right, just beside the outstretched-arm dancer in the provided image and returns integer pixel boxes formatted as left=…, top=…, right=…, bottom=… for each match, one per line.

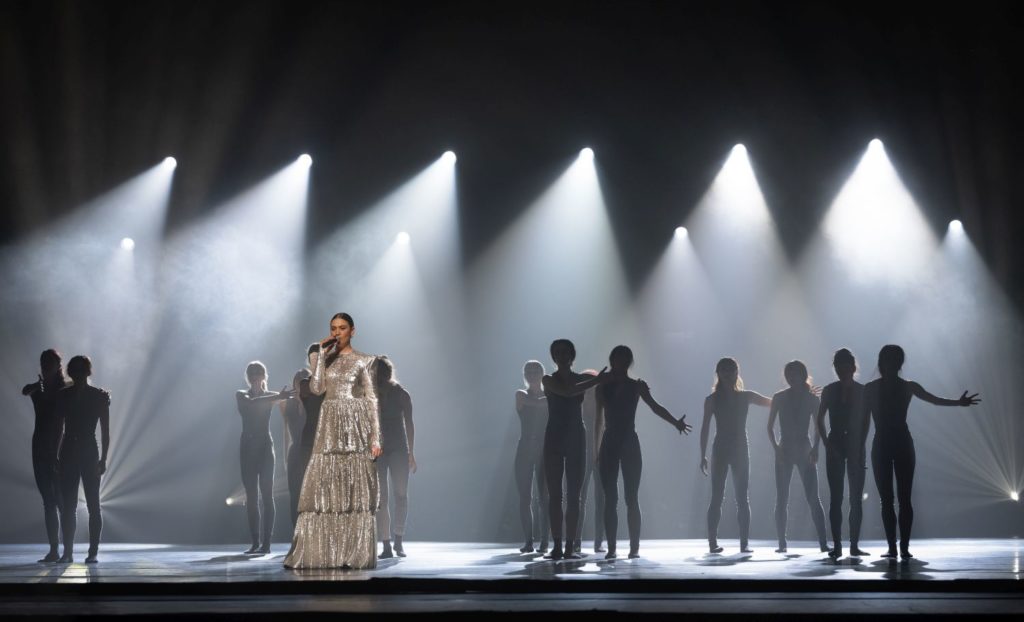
left=817, top=347, right=869, bottom=559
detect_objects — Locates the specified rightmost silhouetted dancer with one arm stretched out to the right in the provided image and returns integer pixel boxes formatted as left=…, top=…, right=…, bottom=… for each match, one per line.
left=864, top=344, right=981, bottom=559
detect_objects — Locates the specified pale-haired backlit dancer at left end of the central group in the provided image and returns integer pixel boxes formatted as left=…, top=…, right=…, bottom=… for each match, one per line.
left=515, top=361, right=549, bottom=553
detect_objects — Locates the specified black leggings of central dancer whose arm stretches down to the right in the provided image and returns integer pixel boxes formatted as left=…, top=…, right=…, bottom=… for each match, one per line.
left=598, top=431, right=643, bottom=552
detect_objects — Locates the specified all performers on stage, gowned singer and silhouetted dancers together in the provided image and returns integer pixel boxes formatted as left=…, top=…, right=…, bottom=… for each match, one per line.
left=23, top=313, right=980, bottom=569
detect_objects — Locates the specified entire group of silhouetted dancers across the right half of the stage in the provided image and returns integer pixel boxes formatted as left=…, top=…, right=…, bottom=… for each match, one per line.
left=515, top=339, right=980, bottom=559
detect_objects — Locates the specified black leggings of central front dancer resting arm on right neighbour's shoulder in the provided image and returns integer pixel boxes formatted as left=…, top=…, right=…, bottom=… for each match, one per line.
left=544, top=424, right=587, bottom=541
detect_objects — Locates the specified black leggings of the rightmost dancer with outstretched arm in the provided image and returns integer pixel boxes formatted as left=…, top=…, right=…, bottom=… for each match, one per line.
left=871, top=430, right=918, bottom=550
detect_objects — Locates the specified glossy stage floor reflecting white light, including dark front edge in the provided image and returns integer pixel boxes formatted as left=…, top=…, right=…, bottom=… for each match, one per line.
left=0, top=539, right=1024, bottom=619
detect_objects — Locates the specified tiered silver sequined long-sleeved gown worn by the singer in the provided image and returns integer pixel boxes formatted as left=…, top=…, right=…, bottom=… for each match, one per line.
left=285, top=347, right=381, bottom=568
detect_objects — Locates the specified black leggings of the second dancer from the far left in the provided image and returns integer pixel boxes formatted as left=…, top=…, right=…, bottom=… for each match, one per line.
left=59, top=446, right=103, bottom=554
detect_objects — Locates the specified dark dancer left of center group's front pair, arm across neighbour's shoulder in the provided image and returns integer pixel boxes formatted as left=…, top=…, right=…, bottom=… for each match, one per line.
left=542, top=339, right=607, bottom=559
